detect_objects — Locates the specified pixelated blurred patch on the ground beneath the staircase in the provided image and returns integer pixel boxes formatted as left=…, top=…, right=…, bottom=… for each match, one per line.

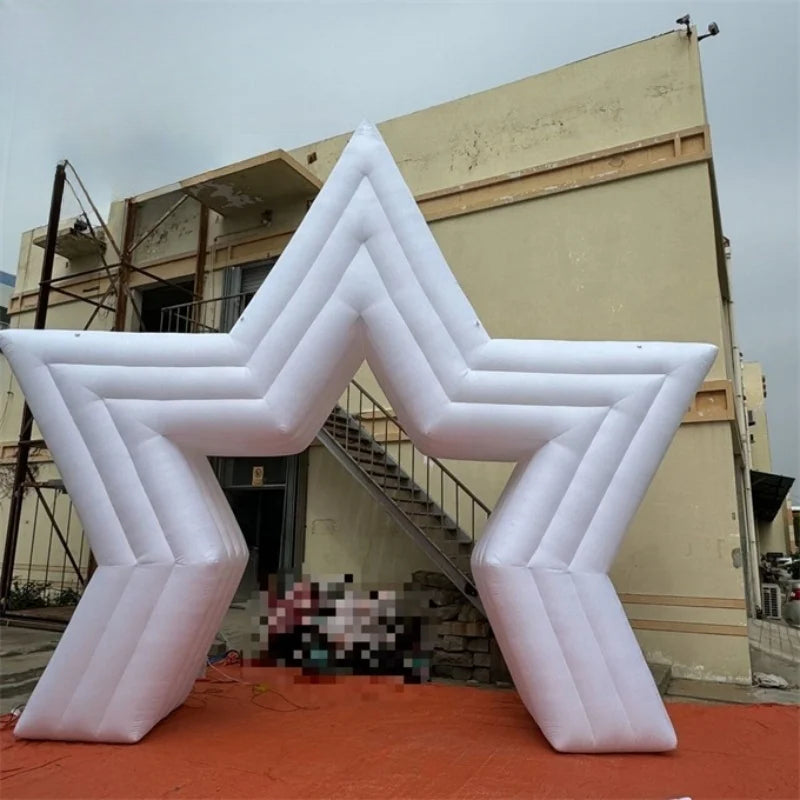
left=248, top=575, right=432, bottom=683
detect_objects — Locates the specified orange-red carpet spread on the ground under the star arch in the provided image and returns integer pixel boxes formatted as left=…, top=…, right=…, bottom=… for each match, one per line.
left=0, top=669, right=800, bottom=800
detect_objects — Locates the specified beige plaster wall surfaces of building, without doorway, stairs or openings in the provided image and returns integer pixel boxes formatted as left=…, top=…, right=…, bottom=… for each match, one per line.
left=3, top=33, right=749, bottom=680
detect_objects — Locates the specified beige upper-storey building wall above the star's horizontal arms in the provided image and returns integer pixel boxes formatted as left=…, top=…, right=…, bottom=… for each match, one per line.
left=6, top=32, right=731, bottom=379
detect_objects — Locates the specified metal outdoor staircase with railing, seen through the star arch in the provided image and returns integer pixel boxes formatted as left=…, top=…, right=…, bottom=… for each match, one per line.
left=317, top=381, right=490, bottom=613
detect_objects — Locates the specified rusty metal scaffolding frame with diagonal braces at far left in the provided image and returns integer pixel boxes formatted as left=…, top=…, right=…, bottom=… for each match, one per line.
left=0, top=160, right=214, bottom=627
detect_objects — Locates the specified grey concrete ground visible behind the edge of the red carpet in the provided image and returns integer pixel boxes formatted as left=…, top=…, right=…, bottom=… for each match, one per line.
left=0, top=604, right=800, bottom=714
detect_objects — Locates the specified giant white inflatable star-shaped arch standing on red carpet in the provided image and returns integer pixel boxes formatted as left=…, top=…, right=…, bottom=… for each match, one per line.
left=0, top=124, right=716, bottom=752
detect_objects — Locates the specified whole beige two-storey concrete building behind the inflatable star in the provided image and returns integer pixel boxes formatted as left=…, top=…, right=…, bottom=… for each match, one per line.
left=0, top=32, right=772, bottom=682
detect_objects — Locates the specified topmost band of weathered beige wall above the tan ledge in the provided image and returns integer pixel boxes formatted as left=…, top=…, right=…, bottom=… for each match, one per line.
left=291, top=33, right=706, bottom=194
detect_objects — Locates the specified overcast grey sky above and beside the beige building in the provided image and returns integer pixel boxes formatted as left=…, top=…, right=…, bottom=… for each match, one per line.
left=0, top=0, right=800, bottom=490
